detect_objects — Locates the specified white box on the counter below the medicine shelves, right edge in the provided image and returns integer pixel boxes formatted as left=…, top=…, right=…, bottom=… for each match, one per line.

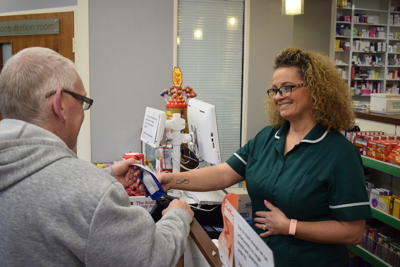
left=370, top=94, right=400, bottom=114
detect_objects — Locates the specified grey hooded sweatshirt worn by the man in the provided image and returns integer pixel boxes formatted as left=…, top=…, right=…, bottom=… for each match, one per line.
left=0, top=119, right=191, bottom=267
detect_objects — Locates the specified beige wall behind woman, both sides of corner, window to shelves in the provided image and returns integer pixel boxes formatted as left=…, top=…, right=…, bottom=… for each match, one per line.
left=242, top=0, right=335, bottom=143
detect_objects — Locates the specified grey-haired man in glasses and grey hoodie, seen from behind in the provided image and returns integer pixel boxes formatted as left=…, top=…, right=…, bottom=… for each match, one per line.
left=0, top=47, right=193, bottom=267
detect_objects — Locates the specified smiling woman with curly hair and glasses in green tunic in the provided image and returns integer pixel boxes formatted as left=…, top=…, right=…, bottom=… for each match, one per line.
left=157, top=48, right=371, bottom=267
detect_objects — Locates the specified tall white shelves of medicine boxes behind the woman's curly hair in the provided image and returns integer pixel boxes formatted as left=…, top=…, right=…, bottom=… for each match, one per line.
left=331, top=0, right=400, bottom=95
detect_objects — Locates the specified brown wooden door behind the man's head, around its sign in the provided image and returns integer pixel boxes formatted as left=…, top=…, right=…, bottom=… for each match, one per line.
left=0, top=12, right=75, bottom=120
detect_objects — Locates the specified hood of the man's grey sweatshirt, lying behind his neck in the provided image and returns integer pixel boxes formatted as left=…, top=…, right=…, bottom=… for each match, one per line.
left=0, top=119, right=77, bottom=192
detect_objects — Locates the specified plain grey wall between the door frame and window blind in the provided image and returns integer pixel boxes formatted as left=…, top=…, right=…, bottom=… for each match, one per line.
left=89, top=0, right=174, bottom=162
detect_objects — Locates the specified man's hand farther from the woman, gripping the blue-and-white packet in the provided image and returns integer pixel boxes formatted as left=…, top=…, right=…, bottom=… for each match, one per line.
left=111, top=158, right=140, bottom=188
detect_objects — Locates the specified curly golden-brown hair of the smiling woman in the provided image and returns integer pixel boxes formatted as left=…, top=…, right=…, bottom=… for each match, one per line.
left=265, top=47, right=355, bottom=131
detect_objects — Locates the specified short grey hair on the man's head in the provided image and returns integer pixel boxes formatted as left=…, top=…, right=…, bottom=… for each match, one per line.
left=0, top=47, right=78, bottom=124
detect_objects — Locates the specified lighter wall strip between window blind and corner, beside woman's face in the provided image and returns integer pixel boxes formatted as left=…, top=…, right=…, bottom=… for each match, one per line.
left=242, top=0, right=293, bottom=144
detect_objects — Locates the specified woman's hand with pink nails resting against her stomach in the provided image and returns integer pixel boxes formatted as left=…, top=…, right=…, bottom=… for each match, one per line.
left=254, top=200, right=290, bottom=237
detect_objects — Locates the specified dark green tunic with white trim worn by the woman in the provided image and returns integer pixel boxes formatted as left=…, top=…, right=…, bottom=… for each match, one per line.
left=227, top=122, right=371, bottom=267
